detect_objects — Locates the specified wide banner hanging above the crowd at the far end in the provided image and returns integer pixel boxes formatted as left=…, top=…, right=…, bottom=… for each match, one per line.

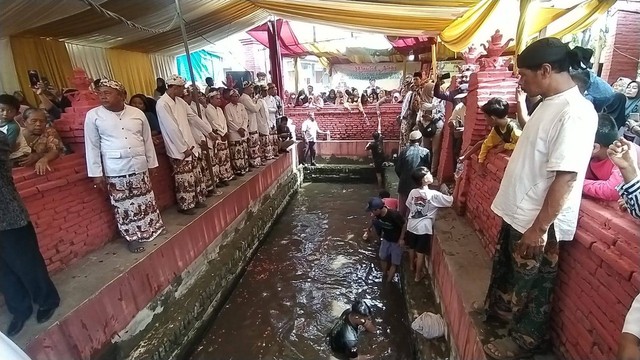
left=331, top=61, right=420, bottom=91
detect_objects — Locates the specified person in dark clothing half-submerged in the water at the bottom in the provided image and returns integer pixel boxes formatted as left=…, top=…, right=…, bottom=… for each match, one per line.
left=328, top=300, right=377, bottom=359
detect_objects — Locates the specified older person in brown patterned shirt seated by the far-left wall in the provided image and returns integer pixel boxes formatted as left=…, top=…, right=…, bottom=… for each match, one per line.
left=20, top=108, right=63, bottom=175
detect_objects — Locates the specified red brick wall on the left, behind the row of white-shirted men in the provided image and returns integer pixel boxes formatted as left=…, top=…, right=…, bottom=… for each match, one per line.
left=13, top=139, right=175, bottom=273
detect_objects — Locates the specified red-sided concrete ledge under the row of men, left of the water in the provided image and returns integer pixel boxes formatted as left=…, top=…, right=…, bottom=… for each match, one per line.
left=13, top=152, right=295, bottom=360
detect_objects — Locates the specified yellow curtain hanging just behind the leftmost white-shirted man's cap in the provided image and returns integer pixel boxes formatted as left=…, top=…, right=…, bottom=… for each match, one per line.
left=107, top=49, right=156, bottom=97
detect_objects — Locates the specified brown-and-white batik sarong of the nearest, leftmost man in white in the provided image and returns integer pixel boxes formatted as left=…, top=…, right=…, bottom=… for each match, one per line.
left=107, top=171, right=164, bottom=242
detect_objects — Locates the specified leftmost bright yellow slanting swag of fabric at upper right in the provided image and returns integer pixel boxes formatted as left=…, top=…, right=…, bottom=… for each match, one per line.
left=440, top=0, right=500, bottom=52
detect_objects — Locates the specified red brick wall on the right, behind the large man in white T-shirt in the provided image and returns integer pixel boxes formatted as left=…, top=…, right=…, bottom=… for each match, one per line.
left=466, top=154, right=640, bottom=359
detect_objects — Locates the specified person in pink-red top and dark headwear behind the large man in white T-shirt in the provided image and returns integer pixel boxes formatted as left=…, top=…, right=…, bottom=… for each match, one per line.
left=582, top=114, right=640, bottom=201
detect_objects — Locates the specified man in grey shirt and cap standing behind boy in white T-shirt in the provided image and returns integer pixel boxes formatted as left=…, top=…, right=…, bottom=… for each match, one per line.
left=395, top=130, right=431, bottom=217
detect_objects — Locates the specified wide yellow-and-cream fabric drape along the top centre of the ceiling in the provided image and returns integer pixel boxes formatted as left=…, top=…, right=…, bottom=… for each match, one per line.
left=250, top=0, right=476, bottom=36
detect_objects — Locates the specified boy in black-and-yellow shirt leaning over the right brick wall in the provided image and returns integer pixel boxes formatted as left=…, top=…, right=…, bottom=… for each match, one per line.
left=476, top=97, right=522, bottom=164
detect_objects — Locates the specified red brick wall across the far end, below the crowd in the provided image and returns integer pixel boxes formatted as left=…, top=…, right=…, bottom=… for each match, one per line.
left=285, top=104, right=402, bottom=140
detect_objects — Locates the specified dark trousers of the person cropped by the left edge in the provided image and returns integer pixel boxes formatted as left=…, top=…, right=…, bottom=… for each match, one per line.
left=0, top=223, right=60, bottom=319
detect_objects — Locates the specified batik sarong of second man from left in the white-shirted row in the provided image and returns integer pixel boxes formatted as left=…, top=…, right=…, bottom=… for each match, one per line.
left=169, top=158, right=207, bottom=210
